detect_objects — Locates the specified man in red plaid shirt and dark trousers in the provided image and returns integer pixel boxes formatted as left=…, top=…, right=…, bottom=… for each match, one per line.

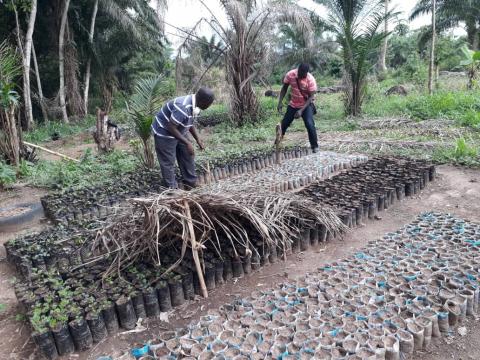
left=277, top=63, right=318, bottom=152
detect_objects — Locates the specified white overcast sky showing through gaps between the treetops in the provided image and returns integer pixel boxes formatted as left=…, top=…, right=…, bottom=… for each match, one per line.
left=165, top=0, right=430, bottom=48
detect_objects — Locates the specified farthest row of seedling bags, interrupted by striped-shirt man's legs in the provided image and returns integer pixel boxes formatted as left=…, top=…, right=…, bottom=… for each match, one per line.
left=41, top=146, right=311, bottom=224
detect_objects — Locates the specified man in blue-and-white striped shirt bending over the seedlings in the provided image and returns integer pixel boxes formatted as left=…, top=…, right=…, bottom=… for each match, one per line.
left=152, top=88, right=214, bottom=189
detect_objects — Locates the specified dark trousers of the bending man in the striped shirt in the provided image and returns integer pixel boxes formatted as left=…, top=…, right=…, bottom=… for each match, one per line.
left=154, top=136, right=197, bottom=189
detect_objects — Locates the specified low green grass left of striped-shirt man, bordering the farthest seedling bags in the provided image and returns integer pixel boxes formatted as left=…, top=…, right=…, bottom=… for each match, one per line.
left=26, top=149, right=138, bottom=189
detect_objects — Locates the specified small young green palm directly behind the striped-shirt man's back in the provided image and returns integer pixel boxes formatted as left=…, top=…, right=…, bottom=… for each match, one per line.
left=127, top=76, right=163, bottom=168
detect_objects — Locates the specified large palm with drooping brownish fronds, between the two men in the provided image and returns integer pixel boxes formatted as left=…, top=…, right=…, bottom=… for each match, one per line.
left=194, top=0, right=312, bottom=125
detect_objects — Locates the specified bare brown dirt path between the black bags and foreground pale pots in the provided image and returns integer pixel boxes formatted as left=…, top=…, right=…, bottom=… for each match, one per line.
left=0, top=166, right=480, bottom=360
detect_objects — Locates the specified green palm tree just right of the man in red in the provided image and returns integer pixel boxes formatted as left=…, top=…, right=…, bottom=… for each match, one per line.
left=316, top=0, right=391, bottom=116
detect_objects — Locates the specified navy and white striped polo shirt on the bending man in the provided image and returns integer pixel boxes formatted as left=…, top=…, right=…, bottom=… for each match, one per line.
left=152, top=94, right=195, bottom=139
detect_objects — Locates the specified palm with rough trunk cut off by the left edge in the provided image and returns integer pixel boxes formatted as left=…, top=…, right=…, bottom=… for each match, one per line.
left=0, top=41, right=21, bottom=166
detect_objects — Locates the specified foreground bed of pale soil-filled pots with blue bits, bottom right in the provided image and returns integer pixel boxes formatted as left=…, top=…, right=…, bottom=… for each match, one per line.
left=138, top=213, right=480, bottom=360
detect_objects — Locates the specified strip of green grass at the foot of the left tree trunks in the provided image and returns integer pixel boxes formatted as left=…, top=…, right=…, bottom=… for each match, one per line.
left=24, top=115, right=96, bottom=144
